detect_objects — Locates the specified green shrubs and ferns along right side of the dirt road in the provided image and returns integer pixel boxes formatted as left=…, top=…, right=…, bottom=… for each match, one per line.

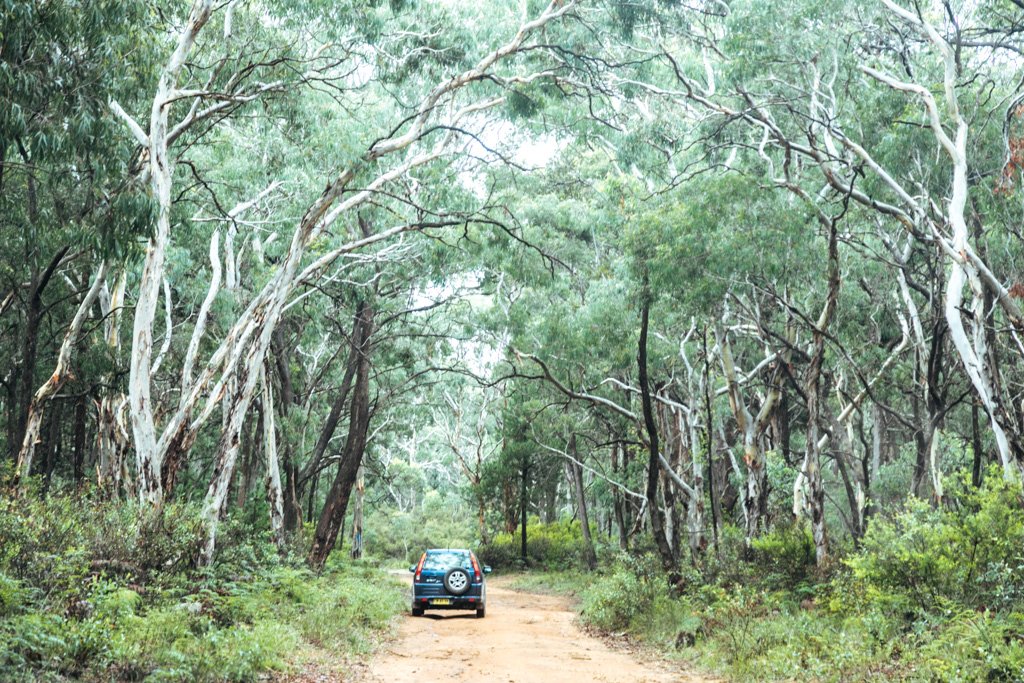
left=575, top=470, right=1024, bottom=683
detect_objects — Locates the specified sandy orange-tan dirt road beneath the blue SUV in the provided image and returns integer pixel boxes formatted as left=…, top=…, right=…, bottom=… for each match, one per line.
left=365, top=578, right=703, bottom=683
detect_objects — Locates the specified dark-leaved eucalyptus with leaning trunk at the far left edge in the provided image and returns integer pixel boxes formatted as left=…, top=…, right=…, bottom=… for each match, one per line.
left=0, top=2, right=156, bottom=479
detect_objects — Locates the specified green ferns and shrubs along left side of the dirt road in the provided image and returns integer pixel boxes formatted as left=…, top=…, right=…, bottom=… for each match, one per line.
left=0, top=497, right=404, bottom=682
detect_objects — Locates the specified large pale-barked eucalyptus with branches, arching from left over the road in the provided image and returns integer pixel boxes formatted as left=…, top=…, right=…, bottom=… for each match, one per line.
left=89, top=2, right=573, bottom=556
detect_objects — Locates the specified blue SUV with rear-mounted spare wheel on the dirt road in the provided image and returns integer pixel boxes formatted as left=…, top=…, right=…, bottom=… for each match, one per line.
left=409, top=549, right=490, bottom=618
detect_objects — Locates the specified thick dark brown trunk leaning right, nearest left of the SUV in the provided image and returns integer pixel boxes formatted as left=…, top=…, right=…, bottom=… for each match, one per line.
left=307, top=304, right=374, bottom=570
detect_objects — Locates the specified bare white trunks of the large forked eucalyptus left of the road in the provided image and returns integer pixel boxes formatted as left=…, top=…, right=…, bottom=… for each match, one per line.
left=111, top=0, right=575, bottom=544
